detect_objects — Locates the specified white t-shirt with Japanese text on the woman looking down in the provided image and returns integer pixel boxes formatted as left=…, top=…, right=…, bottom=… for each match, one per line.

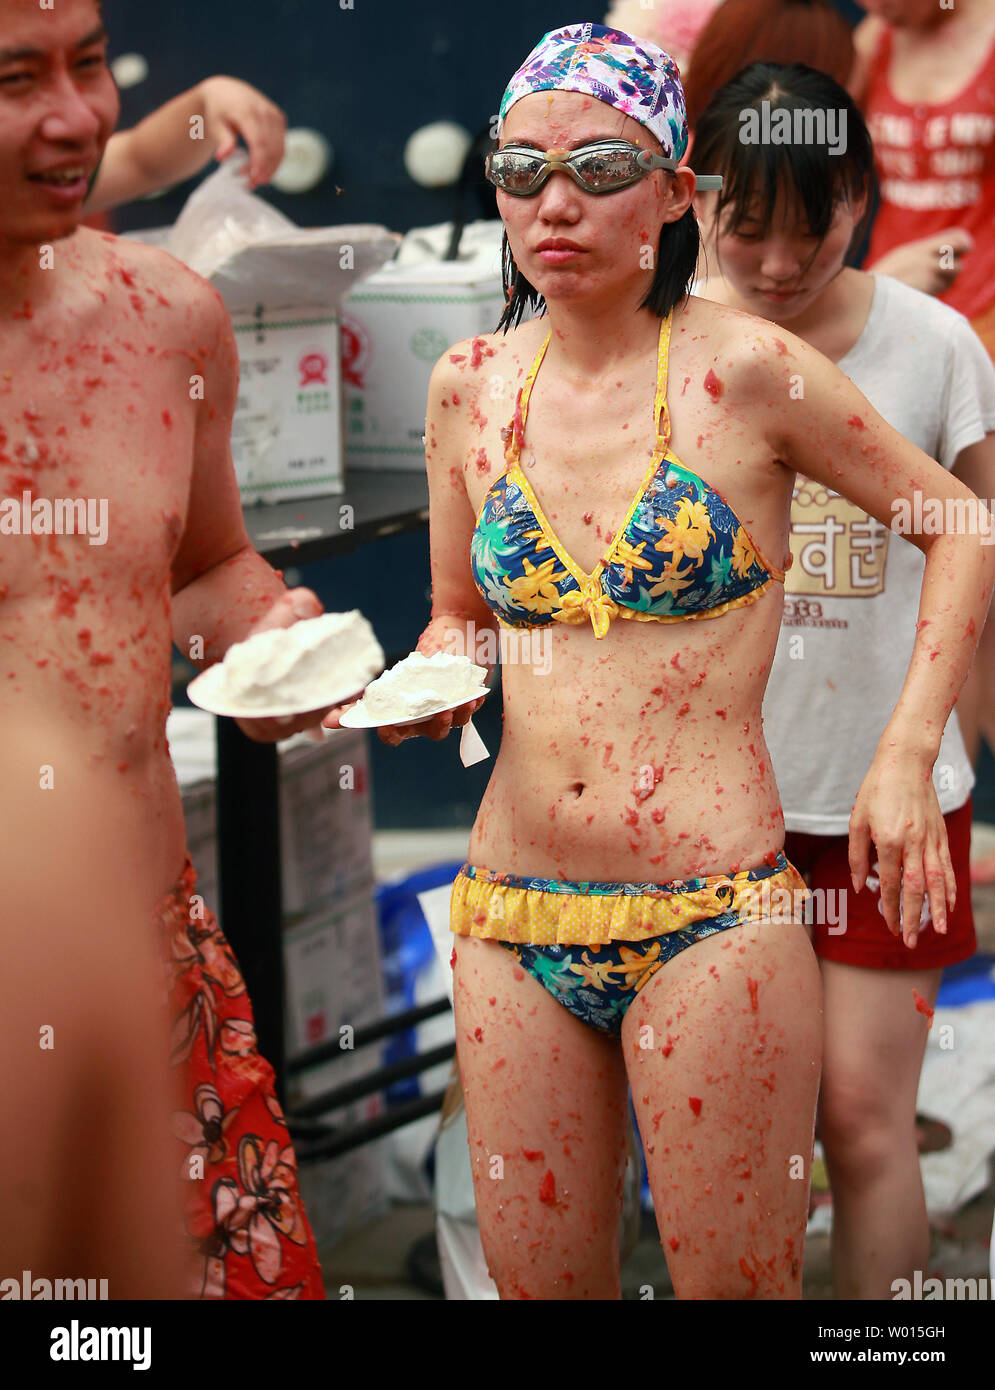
left=763, top=275, right=995, bottom=835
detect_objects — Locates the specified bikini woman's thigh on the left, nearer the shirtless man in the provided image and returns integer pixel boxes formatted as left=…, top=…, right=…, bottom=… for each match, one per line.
left=453, top=937, right=627, bottom=1298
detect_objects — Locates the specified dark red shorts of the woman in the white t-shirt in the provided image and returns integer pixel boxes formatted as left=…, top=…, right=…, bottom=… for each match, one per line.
left=784, top=799, right=977, bottom=970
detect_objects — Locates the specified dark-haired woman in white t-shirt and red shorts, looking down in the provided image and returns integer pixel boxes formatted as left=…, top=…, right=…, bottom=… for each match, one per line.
left=695, top=63, right=995, bottom=1298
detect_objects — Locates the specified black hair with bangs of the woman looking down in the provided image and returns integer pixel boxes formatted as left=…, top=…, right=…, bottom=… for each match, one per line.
left=693, top=63, right=875, bottom=254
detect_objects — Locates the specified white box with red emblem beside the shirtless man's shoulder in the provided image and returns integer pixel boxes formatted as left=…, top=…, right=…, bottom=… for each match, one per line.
left=232, top=306, right=345, bottom=505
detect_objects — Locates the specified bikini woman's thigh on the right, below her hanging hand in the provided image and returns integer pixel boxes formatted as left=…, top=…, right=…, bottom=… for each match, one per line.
left=623, top=922, right=823, bottom=1298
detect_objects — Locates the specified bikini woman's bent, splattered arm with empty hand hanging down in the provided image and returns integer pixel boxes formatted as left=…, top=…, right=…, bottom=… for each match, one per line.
left=753, top=329, right=995, bottom=945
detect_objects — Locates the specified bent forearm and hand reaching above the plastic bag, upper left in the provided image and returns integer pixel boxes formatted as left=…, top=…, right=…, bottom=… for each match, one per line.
left=83, top=76, right=286, bottom=213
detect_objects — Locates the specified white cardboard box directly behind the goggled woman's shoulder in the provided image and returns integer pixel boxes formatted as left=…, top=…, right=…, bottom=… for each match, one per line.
left=342, top=261, right=504, bottom=471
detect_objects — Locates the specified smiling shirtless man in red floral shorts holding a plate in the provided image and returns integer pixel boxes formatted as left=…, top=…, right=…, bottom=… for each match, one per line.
left=0, top=0, right=322, bottom=1298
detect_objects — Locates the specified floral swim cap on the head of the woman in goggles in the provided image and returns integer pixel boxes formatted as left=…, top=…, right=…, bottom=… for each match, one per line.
left=500, top=24, right=688, bottom=160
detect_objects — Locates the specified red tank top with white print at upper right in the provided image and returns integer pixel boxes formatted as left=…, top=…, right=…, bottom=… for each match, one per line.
left=864, top=29, right=995, bottom=318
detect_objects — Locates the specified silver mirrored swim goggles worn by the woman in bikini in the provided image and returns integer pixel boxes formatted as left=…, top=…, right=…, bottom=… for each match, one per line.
left=484, top=140, right=723, bottom=197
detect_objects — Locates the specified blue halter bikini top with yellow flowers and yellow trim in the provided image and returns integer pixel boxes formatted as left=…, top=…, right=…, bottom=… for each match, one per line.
left=470, top=313, right=784, bottom=638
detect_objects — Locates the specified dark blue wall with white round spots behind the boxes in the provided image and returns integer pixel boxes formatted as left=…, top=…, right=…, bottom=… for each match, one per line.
left=103, top=0, right=857, bottom=231
